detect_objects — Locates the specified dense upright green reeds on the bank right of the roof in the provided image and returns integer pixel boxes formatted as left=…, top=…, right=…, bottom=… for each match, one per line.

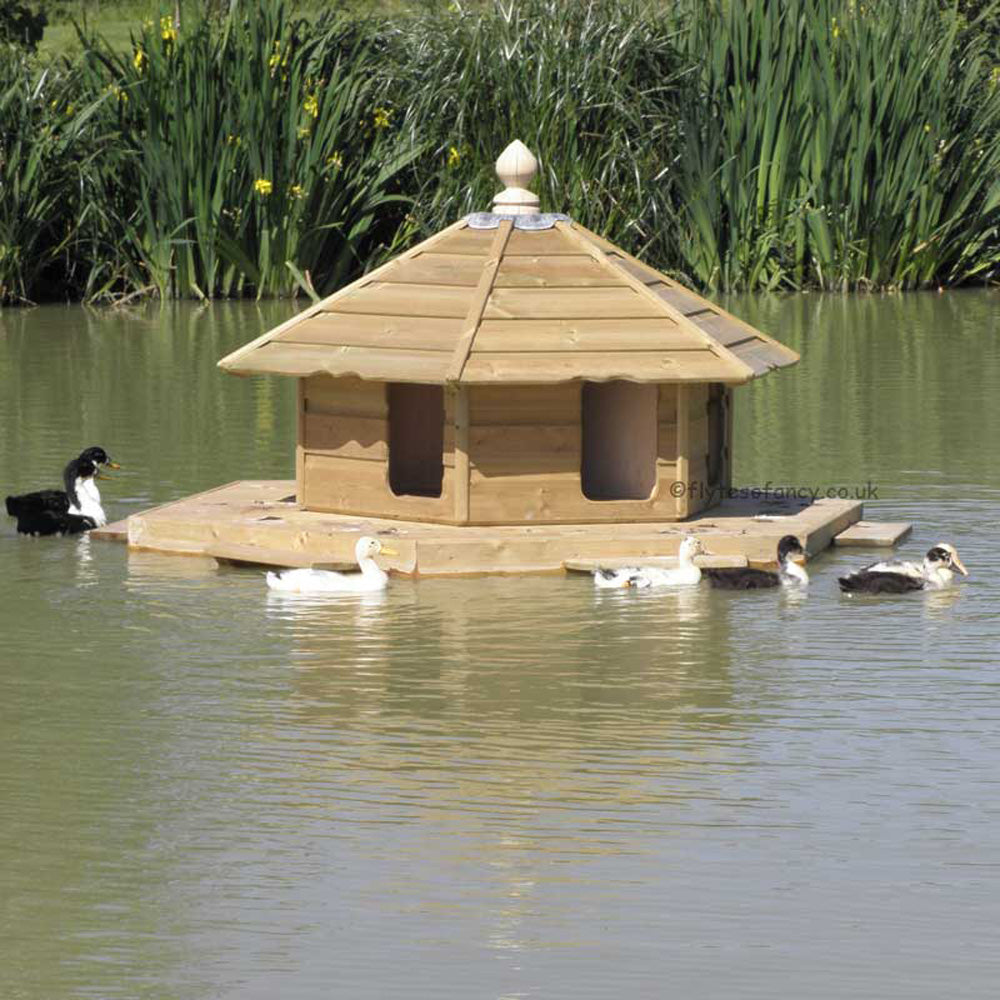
left=671, top=0, right=1000, bottom=289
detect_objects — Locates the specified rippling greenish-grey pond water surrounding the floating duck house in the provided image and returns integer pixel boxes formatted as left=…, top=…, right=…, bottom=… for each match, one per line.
left=0, top=291, right=1000, bottom=1000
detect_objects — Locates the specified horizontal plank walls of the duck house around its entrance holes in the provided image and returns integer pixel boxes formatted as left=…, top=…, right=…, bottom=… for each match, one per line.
left=299, top=375, right=720, bottom=524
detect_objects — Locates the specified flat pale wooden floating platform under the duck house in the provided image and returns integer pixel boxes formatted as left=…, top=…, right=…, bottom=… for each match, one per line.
left=92, top=480, right=862, bottom=576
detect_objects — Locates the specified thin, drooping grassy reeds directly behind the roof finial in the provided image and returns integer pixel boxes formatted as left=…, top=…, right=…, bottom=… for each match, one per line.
left=386, top=0, right=682, bottom=262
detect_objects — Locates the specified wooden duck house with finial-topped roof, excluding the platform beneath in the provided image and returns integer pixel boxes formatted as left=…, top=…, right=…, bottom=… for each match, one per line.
left=220, top=142, right=798, bottom=526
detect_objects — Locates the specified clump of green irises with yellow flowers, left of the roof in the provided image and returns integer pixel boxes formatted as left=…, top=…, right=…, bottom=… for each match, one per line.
left=78, top=2, right=419, bottom=298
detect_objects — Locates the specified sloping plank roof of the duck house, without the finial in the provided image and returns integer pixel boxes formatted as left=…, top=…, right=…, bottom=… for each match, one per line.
left=219, top=184, right=798, bottom=385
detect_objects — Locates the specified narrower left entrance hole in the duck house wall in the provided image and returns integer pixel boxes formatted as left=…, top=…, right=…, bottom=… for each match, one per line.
left=389, top=382, right=444, bottom=497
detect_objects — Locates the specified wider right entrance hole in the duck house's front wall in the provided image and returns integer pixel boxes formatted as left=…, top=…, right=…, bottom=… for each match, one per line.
left=580, top=381, right=659, bottom=500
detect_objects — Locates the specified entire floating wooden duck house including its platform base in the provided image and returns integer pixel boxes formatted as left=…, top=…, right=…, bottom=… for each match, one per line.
left=105, top=142, right=896, bottom=573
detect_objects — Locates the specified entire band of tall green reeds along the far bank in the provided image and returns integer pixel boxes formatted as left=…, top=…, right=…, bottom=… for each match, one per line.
left=0, top=0, right=1000, bottom=302
